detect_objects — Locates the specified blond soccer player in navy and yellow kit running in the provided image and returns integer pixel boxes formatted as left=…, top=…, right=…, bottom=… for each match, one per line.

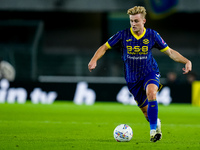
left=88, top=6, right=192, bottom=142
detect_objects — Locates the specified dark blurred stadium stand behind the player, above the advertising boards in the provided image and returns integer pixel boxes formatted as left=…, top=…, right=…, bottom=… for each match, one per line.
left=0, top=0, right=200, bottom=82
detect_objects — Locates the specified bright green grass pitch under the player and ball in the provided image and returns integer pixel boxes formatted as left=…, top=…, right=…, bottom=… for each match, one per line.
left=0, top=102, right=200, bottom=150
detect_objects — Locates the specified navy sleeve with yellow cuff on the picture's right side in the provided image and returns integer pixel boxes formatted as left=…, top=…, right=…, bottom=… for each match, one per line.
left=154, top=31, right=169, bottom=52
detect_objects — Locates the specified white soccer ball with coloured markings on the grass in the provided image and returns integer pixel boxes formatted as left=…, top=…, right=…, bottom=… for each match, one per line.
left=113, top=124, right=133, bottom=142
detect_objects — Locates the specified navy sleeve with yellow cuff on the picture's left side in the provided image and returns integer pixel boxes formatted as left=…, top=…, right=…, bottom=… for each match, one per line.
left=106, top=32, right=121, bottom=49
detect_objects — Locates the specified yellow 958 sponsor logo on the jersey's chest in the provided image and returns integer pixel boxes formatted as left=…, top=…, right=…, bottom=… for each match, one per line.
left=126, top=46, right=148, bottom=55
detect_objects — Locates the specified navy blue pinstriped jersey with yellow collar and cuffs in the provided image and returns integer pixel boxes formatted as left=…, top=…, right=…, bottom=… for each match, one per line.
left=106, top=28, right=169, bottom=83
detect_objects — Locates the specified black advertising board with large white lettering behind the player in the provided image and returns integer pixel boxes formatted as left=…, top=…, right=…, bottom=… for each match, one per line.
left=0, top=79, right=191, bottom=105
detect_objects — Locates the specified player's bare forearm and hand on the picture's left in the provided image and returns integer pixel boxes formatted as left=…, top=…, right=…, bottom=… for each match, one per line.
left=88, top=43, right=109, bottom=72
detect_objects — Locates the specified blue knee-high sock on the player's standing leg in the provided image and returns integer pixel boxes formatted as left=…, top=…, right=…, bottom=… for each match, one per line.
left=147, top=100, right=158, bottom=130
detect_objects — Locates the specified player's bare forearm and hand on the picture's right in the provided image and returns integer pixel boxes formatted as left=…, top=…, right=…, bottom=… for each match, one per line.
left=164, top=48, right=192, bottom=74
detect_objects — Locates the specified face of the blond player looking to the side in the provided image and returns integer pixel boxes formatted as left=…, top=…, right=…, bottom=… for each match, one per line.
left=129, top=14, right=146, bottom=33
